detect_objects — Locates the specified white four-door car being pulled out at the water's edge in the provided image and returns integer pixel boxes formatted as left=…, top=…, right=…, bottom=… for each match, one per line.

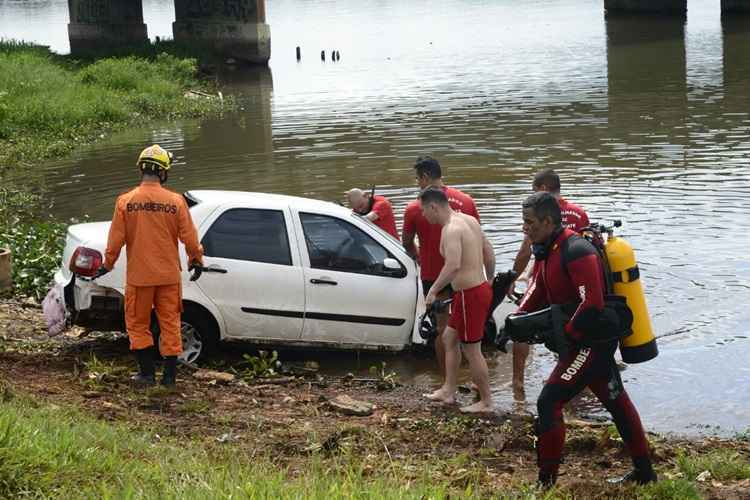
left=55, top=190, right=516, bottom=362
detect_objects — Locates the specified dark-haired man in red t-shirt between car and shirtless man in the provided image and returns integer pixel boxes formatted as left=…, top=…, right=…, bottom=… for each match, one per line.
left=402, top=156, right=495, bottom=374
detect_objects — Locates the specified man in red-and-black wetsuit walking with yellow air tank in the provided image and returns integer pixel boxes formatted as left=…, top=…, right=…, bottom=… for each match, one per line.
left=518, top=192, right=656, bottom=487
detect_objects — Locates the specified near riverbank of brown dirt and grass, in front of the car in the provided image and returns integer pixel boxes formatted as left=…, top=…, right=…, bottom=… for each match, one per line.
left=0, top=301, right=750, bottom=500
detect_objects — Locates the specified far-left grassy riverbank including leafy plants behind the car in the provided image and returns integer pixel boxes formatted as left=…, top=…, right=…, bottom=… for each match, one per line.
left=0, top=41, right=234, bottom=299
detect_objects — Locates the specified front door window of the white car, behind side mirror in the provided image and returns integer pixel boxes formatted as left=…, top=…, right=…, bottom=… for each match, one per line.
left=300, top=213, right=402, bottom=276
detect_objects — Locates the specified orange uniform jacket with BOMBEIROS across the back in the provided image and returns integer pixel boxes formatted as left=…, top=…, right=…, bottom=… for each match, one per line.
left=104, top=182, right=203, bottom=286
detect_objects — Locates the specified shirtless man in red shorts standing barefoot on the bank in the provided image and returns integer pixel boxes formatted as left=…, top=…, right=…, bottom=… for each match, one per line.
left=419, top=187, right=495, bottom=413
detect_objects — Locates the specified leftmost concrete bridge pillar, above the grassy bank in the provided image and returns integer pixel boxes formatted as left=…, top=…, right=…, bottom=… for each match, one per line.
left=68, top=0, right=148, bottom=54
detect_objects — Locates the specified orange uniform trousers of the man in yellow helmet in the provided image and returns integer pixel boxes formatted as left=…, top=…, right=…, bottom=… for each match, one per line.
left=125, top=283, right=182, bottom=356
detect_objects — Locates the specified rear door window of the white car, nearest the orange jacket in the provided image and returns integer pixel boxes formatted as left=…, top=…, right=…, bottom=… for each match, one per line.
left=201, top=208, right=292, bottom=266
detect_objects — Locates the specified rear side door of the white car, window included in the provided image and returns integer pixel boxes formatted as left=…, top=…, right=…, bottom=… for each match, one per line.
left=196, top=204, right=305, bottom=341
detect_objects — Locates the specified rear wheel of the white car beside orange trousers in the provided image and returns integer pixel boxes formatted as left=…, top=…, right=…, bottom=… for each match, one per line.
left=151, top=304, right=219, bottom=364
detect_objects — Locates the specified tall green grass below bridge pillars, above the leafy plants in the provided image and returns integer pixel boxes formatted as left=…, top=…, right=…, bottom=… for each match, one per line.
left=0, top=41, right=227, bottom=166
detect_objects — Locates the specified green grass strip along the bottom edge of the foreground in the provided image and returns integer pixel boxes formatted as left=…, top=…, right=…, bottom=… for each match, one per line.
left=0, top=390, right=745, bottom=500
